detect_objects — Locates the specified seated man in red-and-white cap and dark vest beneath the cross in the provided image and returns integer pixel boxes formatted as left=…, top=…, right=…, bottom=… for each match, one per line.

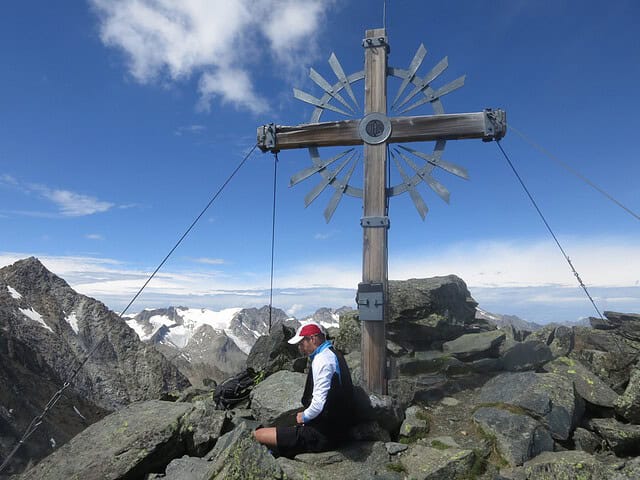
left=254, top=322, right=353, bottom=457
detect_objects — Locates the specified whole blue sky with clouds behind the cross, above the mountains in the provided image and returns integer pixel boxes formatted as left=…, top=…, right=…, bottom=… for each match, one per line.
left=0, top=0, right=640, bottom=323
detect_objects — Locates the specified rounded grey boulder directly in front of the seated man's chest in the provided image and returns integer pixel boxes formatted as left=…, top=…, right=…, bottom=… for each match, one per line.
left=250, top=370, right=306, bottom=426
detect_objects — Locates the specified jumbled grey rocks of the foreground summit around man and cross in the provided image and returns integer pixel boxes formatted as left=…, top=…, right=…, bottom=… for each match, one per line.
left=7, top=264, right=640, bottom=480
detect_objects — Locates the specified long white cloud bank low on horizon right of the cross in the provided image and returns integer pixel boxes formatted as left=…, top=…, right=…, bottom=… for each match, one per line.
left=389, top=237, right=640, bottom=287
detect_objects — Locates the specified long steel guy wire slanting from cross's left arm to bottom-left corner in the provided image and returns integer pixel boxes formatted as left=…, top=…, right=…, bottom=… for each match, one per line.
left=0, top=144, right=258, bottom=473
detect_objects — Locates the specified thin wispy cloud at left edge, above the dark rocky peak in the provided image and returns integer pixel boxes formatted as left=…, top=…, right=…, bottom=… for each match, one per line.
left=0, top=174, right=115, bottom=218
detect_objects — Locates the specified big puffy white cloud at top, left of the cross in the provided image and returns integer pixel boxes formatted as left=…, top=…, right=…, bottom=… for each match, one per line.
left=91, top=0, right=335, bottom=113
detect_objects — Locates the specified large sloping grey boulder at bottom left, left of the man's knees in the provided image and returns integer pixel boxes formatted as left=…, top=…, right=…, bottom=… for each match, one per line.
left=20, top=400, right=225, bottom=480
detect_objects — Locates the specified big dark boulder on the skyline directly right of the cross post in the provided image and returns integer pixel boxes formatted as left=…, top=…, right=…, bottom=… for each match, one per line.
left=387, top=275, right=480, bottom=351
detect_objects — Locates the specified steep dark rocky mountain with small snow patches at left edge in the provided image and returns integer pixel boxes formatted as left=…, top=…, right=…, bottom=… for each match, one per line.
left=0, top=257, right=189, bottom=474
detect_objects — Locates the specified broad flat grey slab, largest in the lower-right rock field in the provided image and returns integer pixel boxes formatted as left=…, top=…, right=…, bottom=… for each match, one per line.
left=478, top=372, right=583, bottom=440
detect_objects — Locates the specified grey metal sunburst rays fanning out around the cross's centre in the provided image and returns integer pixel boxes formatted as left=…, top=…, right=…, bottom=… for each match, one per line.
left=290, top=44, right=469, bottom=223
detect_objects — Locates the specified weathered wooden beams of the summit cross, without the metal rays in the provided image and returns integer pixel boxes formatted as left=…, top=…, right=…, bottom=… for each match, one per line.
left=258, top=29, right=506, bottom=394
